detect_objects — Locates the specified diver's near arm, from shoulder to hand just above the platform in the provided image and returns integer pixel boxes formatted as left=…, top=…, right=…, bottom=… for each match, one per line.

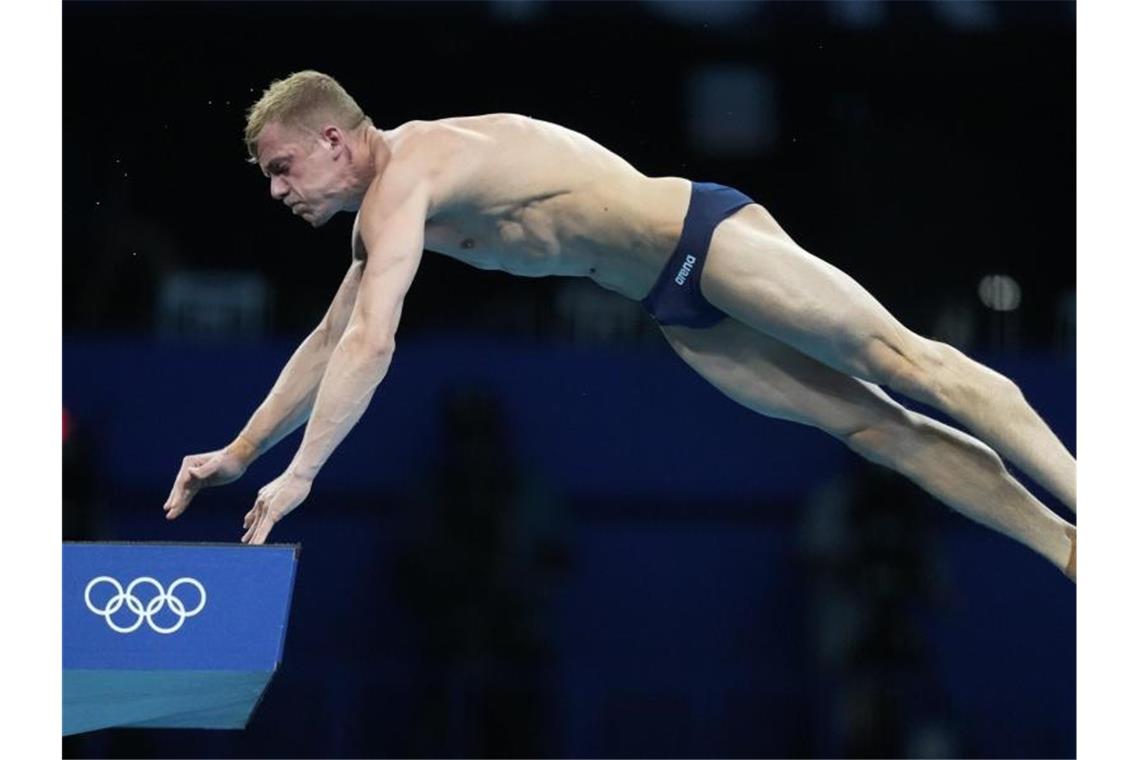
left=242, top=174, right=429, bottom=544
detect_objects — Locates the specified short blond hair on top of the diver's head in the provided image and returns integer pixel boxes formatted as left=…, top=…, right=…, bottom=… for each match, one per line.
left=245, top=70, right=372, bottom=163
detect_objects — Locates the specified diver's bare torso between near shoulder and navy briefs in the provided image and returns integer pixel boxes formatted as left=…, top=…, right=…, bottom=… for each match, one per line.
left=410, top=116, right=690, bottom=300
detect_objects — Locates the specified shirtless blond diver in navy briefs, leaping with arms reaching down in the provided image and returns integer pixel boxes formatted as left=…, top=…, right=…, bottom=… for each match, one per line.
left=164, top=72, right=1076, bottom=580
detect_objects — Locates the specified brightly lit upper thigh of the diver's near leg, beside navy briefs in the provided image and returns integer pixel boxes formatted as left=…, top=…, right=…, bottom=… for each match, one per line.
left=701, top=207, right=923, bottom=384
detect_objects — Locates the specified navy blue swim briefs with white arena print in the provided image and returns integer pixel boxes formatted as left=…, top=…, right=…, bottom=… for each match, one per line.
left=642, top=182, right=756, bottom=327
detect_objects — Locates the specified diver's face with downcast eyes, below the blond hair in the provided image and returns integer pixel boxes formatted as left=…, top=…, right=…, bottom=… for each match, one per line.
left=258, top=122, right=349, bottom=227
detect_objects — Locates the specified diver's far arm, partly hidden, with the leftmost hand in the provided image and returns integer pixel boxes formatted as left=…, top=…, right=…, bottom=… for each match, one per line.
left=163, top=252, right=364, bottom=520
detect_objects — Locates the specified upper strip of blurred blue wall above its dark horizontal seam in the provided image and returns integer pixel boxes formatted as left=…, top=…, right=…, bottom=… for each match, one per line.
left=64, top=336, right=1076, bottom=501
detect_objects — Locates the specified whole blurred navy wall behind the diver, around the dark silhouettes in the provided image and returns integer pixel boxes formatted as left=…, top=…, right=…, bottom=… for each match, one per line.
left=64, top=336, right=1075, bottom=757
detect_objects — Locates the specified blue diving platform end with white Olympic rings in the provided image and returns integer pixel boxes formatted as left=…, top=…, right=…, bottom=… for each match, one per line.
left=63, top=544, right=300, bottom=734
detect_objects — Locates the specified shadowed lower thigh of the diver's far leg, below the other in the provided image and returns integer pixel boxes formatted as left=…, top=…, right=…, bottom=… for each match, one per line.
left=661, top=318, right=909, bottom=438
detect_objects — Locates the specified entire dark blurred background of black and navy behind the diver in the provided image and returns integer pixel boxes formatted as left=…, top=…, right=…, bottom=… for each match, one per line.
left=63, top=2, right=1076, bottom=757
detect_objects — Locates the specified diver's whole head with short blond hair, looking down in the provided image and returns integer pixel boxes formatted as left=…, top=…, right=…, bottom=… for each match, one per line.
left=245, top=71, right=372, bottom=227
